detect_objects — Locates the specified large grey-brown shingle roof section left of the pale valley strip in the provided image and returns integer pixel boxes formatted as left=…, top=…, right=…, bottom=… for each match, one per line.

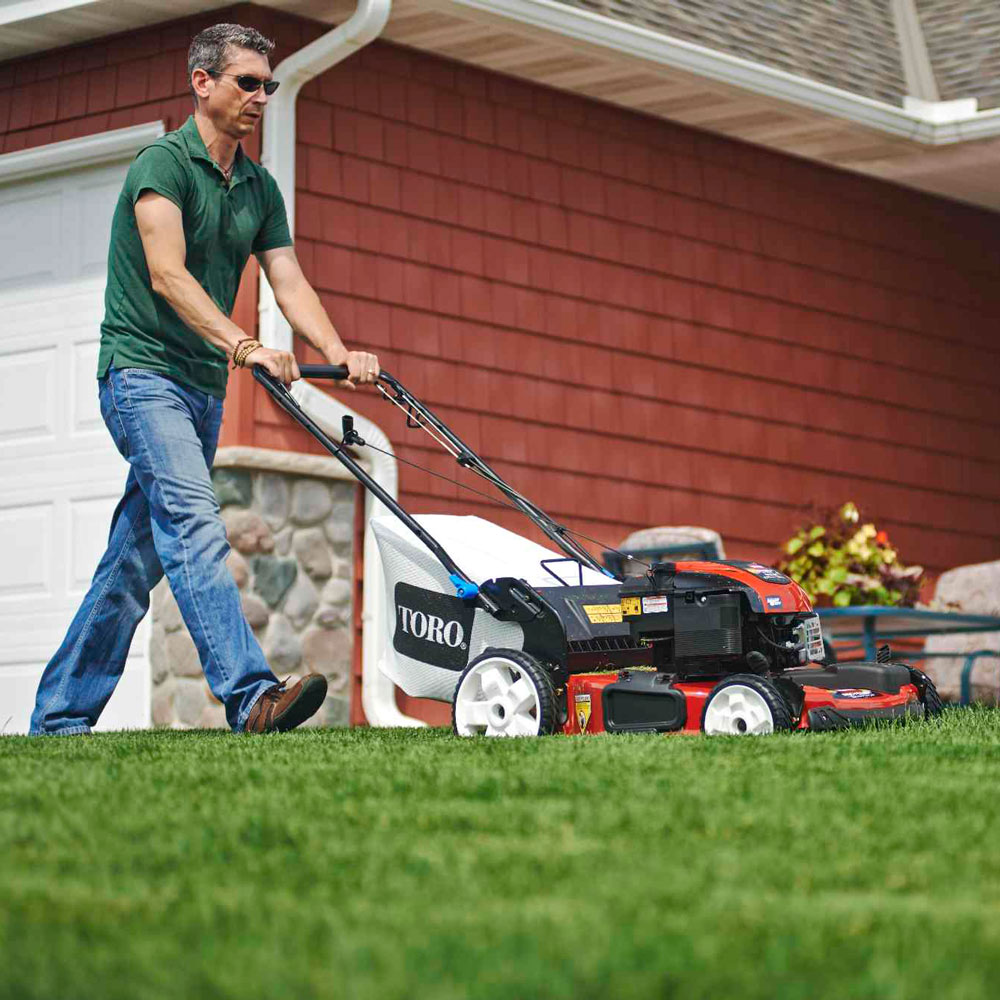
left=563, top=0, right=908, bottom=104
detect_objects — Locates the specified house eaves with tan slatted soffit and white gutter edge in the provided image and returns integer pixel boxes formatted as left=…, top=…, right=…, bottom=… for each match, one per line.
left=0, top=0, right=1000, bottom=209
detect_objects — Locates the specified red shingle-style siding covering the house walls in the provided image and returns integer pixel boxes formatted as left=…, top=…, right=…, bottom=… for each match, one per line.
left=0, top=5, right=1000, bottom=580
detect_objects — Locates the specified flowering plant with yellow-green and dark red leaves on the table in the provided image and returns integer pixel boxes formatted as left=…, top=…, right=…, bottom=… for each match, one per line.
left=778, top=501, right=924, bottom=608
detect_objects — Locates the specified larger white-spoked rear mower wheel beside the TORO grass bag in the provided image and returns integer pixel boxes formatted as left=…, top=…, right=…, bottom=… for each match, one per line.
left=451, top=649, right=556, bottom=736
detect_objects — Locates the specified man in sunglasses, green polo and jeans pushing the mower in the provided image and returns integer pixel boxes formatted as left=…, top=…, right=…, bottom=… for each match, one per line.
left=31, top=24, right=379, bottom=734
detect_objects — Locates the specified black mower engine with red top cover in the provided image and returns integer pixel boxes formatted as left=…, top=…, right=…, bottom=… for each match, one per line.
left=620, top=562, right=823, bottom=677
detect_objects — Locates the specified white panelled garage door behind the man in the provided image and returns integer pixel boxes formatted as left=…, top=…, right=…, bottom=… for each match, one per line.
left=0, top=160, right=150, bottom=733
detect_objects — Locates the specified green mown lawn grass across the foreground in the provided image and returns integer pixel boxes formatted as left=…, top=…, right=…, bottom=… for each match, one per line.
left=0, top=710, right=1000, bottom=1000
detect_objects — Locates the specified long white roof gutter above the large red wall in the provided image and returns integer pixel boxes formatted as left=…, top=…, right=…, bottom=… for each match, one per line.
left=450, top=0, right=1000, bottom=146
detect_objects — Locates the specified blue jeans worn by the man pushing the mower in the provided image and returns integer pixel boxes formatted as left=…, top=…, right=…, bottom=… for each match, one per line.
left=30, top=368, right=278, bottom=734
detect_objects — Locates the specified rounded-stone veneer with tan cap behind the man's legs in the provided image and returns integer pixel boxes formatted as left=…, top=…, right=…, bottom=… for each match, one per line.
left=150, top=448, right=356, bottom=729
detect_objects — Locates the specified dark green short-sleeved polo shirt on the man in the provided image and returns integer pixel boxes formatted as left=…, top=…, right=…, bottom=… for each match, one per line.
left=97, top=116, right=292, bottom=399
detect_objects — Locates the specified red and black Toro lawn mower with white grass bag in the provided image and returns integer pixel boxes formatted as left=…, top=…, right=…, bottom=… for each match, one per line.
left=254, top=365, right=942, bottom=736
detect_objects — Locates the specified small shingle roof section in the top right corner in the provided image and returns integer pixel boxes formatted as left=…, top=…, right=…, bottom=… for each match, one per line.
left=917, top=0, right=1000, bottom=110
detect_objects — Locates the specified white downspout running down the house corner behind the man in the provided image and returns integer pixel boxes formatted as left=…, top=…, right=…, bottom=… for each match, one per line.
left=259, top=0, right=424, bottom=726
